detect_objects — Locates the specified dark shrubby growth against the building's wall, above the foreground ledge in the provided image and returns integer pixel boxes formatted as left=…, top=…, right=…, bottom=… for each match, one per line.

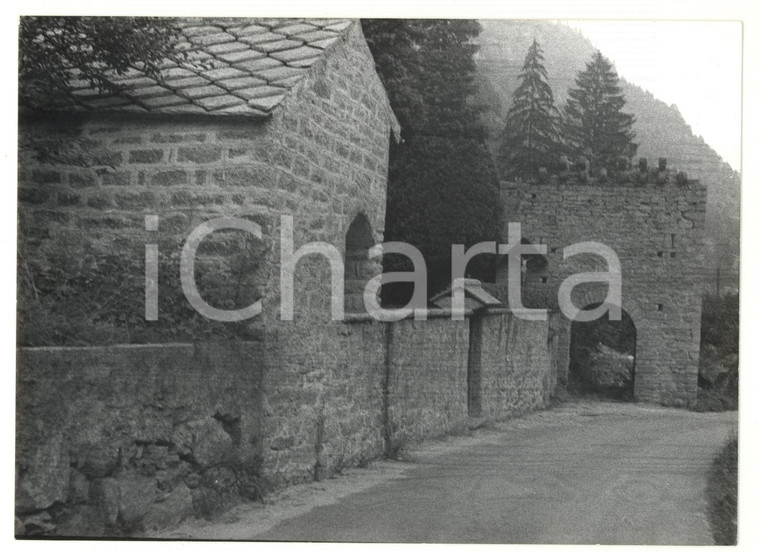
left=17, top=225, right=266, bottom=346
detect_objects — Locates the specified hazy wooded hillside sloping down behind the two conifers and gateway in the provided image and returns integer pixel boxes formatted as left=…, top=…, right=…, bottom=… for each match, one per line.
left=477, top=20, right=741, bottom=289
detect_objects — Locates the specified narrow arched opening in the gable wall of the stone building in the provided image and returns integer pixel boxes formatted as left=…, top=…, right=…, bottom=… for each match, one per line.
left=344, top=213, right=379, bottom=313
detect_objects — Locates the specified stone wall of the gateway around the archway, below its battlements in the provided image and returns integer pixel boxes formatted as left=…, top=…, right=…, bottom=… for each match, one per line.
left=502, top=181, right=706, bottom=406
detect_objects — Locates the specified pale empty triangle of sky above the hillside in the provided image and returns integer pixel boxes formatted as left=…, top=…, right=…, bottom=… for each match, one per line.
left=563, top=20, right=742, bottom=170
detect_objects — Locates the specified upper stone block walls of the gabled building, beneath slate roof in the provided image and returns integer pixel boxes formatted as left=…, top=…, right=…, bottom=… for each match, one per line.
left=18, top=23, right=395, bottom=345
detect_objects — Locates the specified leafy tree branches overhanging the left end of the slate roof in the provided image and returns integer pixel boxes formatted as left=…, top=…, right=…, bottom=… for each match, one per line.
left=18, top=16, right=179, bottom=109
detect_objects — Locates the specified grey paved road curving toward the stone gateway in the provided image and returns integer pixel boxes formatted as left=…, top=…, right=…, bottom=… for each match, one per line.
left=254, top=404, right=736, bottom=545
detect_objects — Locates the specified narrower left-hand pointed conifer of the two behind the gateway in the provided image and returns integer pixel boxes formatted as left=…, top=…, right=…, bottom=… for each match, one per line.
left=499, top=39, right=560, bottom=179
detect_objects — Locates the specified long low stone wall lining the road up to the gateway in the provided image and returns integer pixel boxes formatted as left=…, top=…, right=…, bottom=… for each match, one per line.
left=16, top=306, right=556, bottom=536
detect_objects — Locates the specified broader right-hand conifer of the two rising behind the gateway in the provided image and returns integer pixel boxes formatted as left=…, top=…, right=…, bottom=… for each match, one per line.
left=564, top=51, right=638, bottom=169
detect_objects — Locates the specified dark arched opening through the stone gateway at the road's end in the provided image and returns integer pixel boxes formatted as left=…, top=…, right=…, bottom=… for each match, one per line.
left=567, top=303, right=636, bottom=401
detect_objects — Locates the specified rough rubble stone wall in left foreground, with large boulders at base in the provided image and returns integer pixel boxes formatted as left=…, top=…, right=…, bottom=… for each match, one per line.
left=16, top=343, right=262, bottom=536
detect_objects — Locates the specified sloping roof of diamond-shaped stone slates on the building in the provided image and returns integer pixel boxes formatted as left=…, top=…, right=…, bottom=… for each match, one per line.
left=63, top=18, right=352, bottom=117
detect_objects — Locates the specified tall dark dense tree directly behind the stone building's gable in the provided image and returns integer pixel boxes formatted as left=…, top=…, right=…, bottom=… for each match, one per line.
left=363, top=20, right=500, bottom=302
